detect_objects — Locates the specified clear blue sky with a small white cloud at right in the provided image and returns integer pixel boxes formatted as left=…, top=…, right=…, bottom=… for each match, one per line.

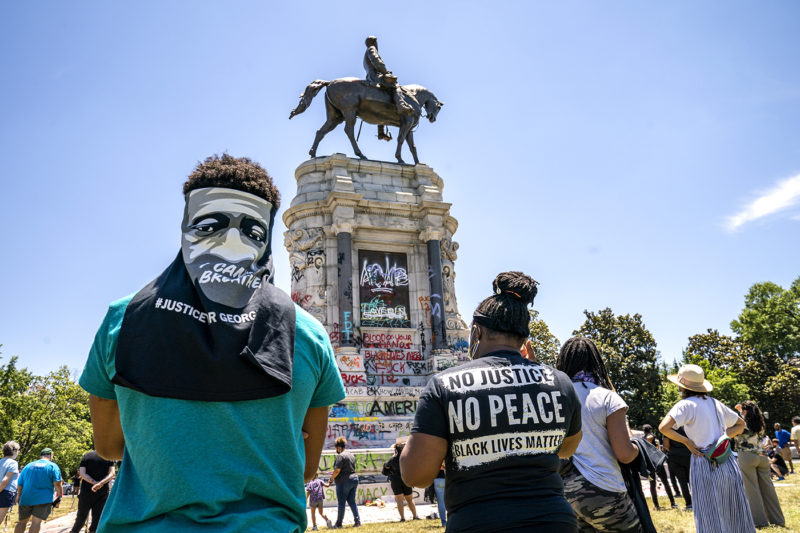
left=0, top=1, right=800, bottom=373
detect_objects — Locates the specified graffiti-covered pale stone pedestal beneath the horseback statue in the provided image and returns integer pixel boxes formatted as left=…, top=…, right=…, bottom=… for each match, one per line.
left=283, top=154, right=468, bottom=502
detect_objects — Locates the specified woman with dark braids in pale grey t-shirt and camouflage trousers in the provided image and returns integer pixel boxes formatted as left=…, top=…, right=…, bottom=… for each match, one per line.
left=556, top=337, right=642, bottom=532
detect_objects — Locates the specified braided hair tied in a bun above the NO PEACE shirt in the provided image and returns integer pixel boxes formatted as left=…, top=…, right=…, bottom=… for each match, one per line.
left=473, top=272, right=539, bottom=339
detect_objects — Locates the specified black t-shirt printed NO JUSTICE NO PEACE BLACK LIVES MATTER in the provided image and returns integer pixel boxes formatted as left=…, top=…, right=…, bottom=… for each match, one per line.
left=411, top=351, right=581, bottom=531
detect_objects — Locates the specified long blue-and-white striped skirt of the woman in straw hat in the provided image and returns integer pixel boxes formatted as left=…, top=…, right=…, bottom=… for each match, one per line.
left=689, top=455, right=756, bottom=533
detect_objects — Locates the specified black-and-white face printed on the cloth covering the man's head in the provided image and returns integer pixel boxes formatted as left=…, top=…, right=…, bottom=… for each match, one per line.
left=181, top=187, right=273, bottom=308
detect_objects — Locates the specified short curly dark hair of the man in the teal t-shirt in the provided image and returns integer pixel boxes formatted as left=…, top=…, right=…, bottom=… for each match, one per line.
left=183, top=154, right=281, bottom=209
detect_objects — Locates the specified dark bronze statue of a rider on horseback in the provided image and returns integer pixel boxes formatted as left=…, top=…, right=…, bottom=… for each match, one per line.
left=289, top=36, right=444, bottom=164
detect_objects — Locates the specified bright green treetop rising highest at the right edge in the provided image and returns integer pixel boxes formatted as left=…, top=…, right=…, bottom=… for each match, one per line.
left=731, top=277, right=800, bottom=362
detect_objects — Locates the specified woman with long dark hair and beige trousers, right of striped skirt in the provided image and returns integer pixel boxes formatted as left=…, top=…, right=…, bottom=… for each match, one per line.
left=736, top=400, right=786, bottom=527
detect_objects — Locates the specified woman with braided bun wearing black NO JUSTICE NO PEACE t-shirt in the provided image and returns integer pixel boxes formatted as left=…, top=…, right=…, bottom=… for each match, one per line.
left=400, top=272, right=581, bottom=533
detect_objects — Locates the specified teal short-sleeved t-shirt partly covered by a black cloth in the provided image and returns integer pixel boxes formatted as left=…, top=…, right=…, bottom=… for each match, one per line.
left=79, top=295, right=345, bottom=533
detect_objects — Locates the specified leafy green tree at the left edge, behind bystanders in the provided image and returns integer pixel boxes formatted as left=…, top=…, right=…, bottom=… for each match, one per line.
left=0, top=350, right=92, bottom=474
